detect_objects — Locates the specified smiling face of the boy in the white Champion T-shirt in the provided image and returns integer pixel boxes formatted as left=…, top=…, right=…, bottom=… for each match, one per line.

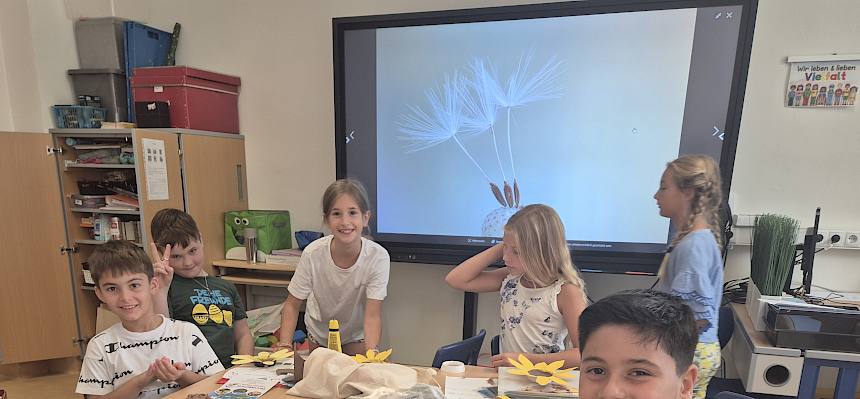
left=96, top=273, right=158, bottom=331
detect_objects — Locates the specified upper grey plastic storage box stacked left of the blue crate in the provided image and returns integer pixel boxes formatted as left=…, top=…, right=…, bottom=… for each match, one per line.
left=75, top=17, right=126, bottom=69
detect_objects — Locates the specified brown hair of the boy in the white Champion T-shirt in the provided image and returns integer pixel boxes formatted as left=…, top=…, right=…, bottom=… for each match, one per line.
left=87, top=240, right=153, bottom=287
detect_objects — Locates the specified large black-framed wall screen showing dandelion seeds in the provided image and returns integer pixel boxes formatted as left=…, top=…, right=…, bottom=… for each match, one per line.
left=333, top=0, right=755, bottom=273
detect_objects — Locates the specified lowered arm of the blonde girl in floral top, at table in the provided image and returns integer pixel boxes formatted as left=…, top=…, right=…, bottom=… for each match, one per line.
left=492, top=284, right=587, bottom=368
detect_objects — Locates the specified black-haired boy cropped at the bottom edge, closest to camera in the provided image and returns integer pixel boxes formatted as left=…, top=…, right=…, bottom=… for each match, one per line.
left=579, top=290, right=699, bottom=399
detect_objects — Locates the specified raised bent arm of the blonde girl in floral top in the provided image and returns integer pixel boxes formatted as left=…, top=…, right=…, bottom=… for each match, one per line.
left=445, top=244, right=508, bottom=292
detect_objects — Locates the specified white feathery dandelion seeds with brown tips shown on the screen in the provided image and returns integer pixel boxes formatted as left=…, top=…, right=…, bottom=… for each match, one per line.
left=397, top=52, right=562, bottom=237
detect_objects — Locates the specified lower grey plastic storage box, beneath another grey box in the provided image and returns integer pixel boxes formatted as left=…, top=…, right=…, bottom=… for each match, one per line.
left=69, top=69, right=129, bottom=122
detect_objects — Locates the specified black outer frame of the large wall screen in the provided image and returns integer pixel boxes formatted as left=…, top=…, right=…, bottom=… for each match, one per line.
left=332, top=0, right=758, bottom=275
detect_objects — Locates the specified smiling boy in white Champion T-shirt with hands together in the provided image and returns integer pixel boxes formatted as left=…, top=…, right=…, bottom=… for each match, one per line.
left=75, top=241, right=224, bottom=398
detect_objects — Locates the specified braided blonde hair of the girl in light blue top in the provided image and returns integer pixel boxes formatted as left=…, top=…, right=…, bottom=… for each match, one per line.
left=666, top=155, right=723, bottom=247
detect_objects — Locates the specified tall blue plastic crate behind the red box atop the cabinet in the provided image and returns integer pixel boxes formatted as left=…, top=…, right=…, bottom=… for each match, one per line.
left=124, top=21, right=173, bottom=122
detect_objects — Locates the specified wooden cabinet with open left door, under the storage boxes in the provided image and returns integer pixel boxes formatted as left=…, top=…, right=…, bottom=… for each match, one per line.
left=0, top=129, right=247, bottom=364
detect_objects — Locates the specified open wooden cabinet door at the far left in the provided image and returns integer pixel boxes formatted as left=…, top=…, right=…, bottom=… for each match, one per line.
left=0, top=133, right=79, bottom=363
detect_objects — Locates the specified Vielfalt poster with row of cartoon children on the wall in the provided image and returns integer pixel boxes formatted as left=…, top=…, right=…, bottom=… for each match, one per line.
left=785, top=57, right=860, bottom=108
